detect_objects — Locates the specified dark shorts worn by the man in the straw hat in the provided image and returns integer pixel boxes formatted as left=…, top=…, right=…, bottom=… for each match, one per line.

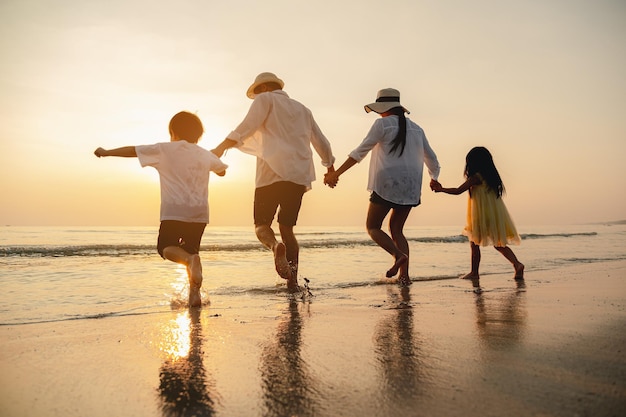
left=254, top=181, right=306, bottom=226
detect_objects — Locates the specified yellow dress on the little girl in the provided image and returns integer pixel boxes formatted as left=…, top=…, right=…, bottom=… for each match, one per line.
left=463, top=176, right=521, bottom=247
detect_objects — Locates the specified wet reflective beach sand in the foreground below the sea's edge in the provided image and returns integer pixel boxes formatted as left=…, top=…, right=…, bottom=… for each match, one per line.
left=0, top=261, right=626, bottom=417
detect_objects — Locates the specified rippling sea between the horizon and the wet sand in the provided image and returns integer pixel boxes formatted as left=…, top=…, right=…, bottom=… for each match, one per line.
left=0, top=223, right=626, bottom=326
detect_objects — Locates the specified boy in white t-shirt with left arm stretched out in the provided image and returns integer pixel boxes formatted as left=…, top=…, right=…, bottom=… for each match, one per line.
left=94, top=112, right=228, bottom=307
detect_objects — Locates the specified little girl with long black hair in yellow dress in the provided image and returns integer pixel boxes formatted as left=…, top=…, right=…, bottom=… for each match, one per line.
left=431, top=146, right=524, bottom=280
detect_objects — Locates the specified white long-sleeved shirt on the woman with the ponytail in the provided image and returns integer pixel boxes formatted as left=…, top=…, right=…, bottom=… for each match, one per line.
left=350, top=116, right=440, bottom=205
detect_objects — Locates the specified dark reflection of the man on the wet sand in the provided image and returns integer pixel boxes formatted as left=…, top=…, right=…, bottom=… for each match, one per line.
left=260, top=300, right=320, bottom=416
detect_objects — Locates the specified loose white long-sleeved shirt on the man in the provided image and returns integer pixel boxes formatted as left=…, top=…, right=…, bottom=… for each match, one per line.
left=227, top=90, right=335, bottom=190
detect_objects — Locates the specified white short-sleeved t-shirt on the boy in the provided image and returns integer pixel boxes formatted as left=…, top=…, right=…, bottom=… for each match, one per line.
left=135, top=140, right=228, bottom=223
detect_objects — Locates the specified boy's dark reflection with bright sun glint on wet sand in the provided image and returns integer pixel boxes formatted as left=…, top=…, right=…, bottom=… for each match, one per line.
left=159, top=308, right=218, bottom=417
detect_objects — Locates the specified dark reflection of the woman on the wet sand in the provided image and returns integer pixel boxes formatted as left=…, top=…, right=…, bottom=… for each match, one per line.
left=374, top=287, right=423, bottom=415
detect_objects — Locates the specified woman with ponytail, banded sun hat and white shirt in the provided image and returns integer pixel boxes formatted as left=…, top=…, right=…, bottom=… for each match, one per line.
left=324, top=88, right=440, bottom=285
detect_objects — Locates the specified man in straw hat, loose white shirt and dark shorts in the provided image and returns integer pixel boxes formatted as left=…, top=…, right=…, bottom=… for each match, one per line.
left=213, top=72, right=335, bottom=291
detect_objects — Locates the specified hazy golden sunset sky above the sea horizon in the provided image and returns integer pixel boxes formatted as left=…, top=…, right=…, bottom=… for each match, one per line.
left=0, top=0, right=626, bottom=231
